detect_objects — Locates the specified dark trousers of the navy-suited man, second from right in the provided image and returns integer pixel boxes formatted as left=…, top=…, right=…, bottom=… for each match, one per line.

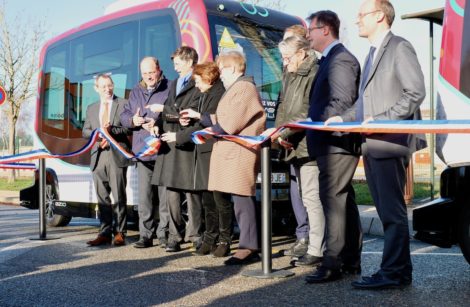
left=316, top=154, right=362, bottom=270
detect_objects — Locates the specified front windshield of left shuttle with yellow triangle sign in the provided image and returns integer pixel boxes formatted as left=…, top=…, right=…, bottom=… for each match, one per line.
left=208, top=14, right=284, bottom=126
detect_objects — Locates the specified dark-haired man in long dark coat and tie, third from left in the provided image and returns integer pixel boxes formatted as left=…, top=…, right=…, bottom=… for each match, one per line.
left=147, top=46, right=202, bottom=252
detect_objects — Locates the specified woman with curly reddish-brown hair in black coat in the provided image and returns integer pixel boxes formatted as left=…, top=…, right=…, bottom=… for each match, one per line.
left=180, top=62, right=232, bottom=257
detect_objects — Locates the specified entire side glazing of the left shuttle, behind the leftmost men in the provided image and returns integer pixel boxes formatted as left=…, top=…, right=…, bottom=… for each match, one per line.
left=40, top=9, right=181, bottom=141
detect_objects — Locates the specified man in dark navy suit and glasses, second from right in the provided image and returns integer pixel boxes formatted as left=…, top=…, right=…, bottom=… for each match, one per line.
left=306, top=11, right=362, bottom=283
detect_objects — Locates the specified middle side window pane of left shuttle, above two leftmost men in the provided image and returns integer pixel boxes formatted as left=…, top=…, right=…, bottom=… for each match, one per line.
left=68, top=21, right=138, bottom=138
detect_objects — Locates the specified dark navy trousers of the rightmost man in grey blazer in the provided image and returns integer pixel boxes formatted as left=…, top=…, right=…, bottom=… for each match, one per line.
left=364, top=155, right=413, bottom=280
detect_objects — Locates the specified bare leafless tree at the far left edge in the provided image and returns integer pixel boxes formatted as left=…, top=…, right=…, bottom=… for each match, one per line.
left=0, top=3, right=44, bottom=182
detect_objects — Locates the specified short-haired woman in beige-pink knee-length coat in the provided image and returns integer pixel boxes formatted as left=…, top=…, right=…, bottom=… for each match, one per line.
left=209, top=52, right=266, bottom=265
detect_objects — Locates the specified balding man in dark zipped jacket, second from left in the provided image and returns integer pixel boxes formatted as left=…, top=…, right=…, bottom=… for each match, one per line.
left=121, top=56, right=170, bottom=248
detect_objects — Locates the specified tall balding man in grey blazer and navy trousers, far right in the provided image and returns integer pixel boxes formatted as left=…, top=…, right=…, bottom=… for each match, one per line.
left=328, top=0, right=426, bottom=289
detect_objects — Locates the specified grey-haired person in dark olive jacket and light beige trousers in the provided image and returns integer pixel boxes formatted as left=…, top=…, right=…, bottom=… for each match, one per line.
left=272, top=35, right=325, bottom=266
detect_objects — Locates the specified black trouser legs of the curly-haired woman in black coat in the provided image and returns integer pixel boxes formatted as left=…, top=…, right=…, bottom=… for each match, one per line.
left=202, top=191, right=233, bottom=245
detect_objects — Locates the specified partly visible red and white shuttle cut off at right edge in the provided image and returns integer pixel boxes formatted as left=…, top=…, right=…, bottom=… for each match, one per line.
left=413, top=0, right=470, bottom=263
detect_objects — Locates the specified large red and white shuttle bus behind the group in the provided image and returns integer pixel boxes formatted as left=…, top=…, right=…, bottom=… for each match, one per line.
left=20, top=0, right=303, bottom=230
